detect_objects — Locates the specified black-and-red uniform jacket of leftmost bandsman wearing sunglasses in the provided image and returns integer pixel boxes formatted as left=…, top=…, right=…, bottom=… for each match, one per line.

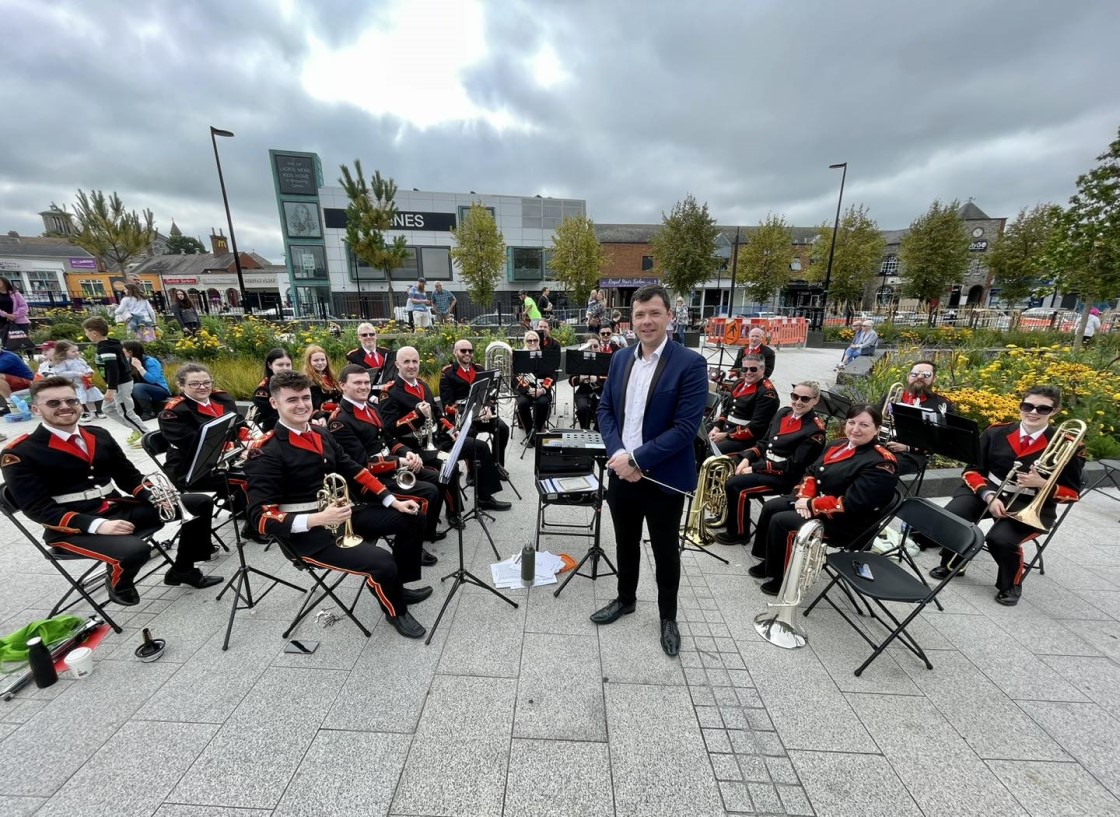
left=0, top=426, right=151, bottom=538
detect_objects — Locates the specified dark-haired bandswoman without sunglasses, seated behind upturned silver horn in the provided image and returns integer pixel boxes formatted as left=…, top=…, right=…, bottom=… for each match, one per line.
left=747, top=403, right=898, bottom=596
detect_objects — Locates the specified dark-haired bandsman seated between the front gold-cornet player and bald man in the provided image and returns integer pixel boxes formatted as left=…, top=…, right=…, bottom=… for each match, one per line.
left=327, top=363, right=447, bottom=558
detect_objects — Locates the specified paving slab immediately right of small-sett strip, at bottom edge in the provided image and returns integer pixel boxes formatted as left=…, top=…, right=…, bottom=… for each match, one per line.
left=790, top=751, right=918, bottom=817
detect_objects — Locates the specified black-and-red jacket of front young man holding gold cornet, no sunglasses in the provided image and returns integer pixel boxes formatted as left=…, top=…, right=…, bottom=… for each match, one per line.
left=245, top=425, right=389, bottom=556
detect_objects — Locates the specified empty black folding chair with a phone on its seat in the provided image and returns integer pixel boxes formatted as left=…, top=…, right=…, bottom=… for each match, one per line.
left=804, top=498, right=983, bottom=677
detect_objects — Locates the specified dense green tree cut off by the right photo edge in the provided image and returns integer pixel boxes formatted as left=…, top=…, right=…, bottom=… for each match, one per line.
left=1048, top=126, right=1120, bottom=347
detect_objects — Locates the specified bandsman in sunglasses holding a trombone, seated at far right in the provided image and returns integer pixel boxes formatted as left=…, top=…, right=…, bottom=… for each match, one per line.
left=930, top=386, right=1085, bottom=607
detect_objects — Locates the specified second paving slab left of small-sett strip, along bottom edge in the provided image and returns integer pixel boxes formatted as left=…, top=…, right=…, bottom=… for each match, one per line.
left=502, top=739, right=615, bottom=817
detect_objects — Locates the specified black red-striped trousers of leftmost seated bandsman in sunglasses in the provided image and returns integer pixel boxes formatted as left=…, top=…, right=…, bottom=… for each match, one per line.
left=44, top=493, right=214, bottom=589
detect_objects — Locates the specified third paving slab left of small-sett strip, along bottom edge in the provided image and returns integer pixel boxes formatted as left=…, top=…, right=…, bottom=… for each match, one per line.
left=392, top=675, right=516, bottom=815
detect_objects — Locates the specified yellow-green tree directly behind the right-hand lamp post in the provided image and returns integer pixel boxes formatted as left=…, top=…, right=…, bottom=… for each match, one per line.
left=805, top=204, right=886, bottom=308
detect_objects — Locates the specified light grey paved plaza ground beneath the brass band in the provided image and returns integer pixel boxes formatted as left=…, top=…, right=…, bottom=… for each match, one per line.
left=0, top=350, right=1120, bottom=817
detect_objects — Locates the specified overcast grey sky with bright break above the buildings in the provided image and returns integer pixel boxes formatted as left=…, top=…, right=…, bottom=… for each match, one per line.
left=0, top=0, right=1120, bottom=261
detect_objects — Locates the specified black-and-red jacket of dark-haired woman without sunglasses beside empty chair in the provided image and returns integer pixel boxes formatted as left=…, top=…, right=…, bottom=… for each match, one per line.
left=794, top=439, right=898, bottom=526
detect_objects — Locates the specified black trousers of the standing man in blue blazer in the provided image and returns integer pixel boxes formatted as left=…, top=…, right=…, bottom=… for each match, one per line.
left=607, top=476, right=684, bottom=621
